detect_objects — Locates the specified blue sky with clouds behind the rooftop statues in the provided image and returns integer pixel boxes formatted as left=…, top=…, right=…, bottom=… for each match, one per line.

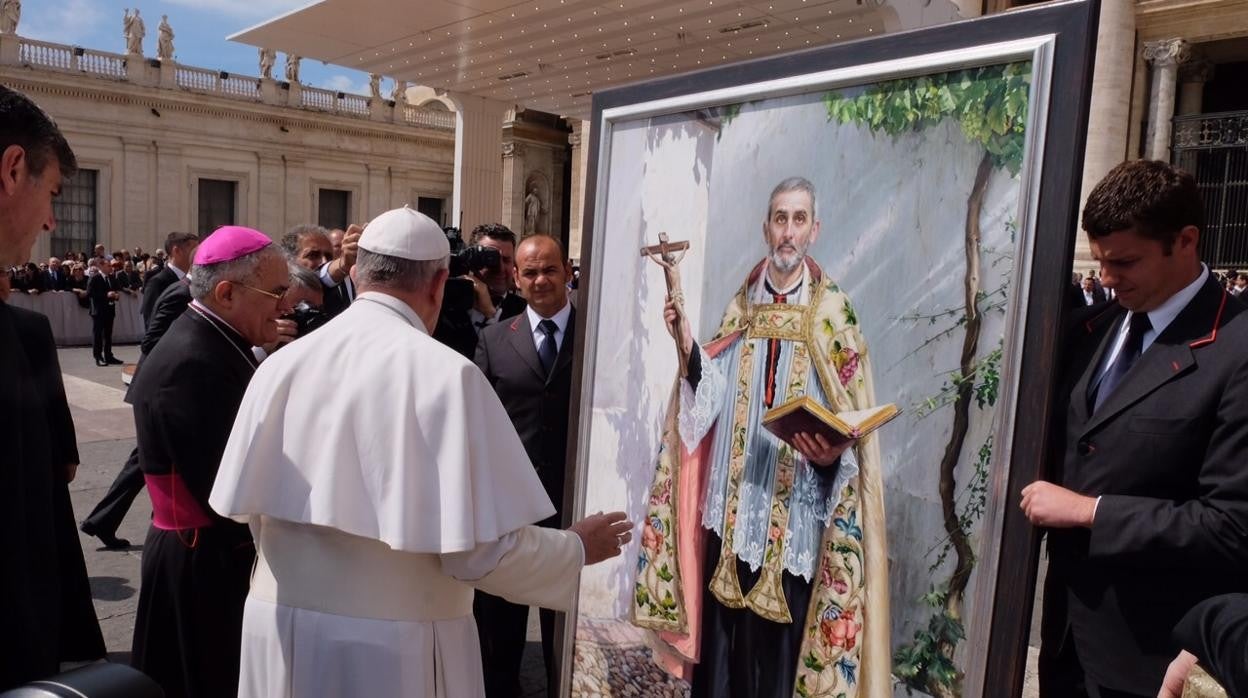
left=17, top=0, right=371, bottom=94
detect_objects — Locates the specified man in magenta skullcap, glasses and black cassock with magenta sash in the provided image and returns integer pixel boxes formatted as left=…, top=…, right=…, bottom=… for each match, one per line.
left=129, top=226, right=290, bottom=697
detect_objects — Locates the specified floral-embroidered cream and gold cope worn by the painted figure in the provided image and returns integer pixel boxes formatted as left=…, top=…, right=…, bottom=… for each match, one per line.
left=633, top=258, right=892, bottom=698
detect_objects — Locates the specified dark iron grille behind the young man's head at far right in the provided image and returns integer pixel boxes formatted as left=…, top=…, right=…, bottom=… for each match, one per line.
left=1172, top=111, right=1248, bottom=270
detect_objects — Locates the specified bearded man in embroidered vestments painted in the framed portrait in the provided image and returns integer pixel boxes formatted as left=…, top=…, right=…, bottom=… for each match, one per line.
left=633, top=177, right=891, bottom=698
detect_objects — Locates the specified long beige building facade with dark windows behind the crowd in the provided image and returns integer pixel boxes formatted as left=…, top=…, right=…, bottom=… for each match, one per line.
left=0, top=34, right=456, bottom=258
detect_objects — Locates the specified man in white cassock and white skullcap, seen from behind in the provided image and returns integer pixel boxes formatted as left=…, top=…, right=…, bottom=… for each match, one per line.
left=210, top=207, right=631, bottom=698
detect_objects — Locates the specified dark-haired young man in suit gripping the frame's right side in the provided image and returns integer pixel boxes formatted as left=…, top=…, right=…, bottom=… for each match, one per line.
left=1021, top=161, right=1248, bottom=698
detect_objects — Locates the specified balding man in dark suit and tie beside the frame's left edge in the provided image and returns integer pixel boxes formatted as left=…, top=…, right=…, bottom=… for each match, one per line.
left=473, top=235, right=577, bottom=698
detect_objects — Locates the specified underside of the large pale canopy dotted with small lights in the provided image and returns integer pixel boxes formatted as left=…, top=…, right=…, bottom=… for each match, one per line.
left=231, top=0, right=957, bottom=119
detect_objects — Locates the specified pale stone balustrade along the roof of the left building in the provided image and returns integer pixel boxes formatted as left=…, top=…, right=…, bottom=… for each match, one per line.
left=0, top=35, right=456, bottom=131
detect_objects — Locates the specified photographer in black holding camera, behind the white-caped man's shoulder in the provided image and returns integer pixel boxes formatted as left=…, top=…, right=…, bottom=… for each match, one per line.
left=433, top=224, right=525, bottom=358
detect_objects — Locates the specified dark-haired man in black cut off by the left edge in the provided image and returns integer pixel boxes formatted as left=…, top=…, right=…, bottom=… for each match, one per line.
left=0, top=86, right=92, bottom=692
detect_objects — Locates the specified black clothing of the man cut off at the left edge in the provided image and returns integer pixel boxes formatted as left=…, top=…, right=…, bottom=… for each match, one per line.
left=0, top=302, right=105, bottom=691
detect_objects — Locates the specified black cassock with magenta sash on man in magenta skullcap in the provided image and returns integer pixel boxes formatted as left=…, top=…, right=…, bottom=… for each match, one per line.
left=130, top=305, right=257, bottom=698
